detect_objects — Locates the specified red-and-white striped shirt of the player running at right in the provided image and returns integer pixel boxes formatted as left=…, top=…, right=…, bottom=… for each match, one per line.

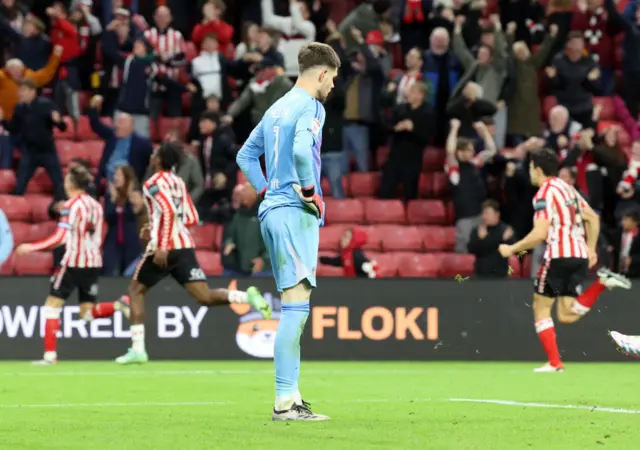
left=533, top=178, right=589, bottom=260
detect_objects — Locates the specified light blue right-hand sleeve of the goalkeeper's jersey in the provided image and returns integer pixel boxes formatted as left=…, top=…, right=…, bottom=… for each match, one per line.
left=293, top=101, right=325, bottom=187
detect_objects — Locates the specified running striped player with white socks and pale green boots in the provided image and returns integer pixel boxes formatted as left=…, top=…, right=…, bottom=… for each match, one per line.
left=116, top=142, right=271, bottom=364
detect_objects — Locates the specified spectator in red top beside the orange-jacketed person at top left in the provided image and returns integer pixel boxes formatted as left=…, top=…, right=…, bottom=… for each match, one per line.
left=47, top=2, right=82, bottom=123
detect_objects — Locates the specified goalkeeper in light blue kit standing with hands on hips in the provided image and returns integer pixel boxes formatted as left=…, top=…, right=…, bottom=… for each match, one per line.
left=236, top=42, right=340, bottom=420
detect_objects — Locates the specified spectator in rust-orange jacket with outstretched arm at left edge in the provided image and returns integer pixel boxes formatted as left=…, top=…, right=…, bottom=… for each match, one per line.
left=0, top=46, right=63, bottom=120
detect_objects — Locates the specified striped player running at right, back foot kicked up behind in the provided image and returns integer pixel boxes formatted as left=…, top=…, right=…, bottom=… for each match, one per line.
left=499, top=148, right=631, bottom=372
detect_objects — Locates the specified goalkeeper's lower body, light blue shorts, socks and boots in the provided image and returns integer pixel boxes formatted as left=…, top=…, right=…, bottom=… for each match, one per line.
left=261, top=208, right=328, bottom=420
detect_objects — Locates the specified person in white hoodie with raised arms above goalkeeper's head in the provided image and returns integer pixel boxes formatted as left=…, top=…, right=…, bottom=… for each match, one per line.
left=261, top=0, right=316, bottom=77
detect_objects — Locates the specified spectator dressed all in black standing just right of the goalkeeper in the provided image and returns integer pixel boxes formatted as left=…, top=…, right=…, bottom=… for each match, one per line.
left=380, top=82, right=433, bottom=200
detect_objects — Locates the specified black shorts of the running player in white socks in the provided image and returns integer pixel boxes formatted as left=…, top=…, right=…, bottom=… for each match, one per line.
left=133, top=248, right=207, bottom=288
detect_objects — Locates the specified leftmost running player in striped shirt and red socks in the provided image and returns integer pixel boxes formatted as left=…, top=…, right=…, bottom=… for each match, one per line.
left=16, top=166, right=129, bottom=365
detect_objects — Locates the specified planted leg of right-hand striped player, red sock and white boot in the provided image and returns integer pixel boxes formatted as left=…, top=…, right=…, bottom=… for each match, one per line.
left=533, top=261, right=563, bottom=372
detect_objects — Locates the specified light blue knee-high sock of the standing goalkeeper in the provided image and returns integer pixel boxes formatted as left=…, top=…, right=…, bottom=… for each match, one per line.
left=274, top=300, right=309, bottom=411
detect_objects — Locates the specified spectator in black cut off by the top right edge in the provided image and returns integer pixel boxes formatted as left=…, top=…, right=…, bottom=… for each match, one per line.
left=604, top=0, right=640, bottom=120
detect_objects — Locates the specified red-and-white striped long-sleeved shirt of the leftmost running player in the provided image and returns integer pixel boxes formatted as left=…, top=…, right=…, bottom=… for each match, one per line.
left=31, top=193, right=104, bottom=269
